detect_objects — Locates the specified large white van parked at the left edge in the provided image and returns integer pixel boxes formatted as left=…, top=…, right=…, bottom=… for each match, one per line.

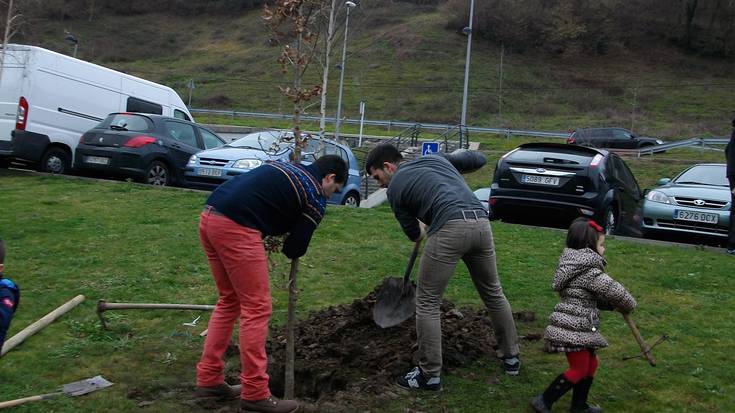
left=0, top=44, right=192, bottom=173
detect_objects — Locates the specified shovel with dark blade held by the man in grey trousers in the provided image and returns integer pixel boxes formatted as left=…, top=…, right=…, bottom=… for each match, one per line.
left=373, top=241, right=421, bottom=328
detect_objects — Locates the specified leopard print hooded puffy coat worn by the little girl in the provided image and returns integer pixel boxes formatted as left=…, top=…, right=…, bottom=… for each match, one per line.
left=544, top=248, right=636, bottom=352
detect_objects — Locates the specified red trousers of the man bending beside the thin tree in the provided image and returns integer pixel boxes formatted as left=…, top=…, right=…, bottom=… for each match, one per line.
left=197, top=211, right=271, bottom=400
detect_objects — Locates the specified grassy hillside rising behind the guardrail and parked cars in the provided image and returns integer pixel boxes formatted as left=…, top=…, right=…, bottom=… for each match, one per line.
left=15, top=3, right=735, bottom=139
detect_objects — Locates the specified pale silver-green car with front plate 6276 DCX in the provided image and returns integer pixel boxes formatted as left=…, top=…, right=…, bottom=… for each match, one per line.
left=641, top=163, right=730, bottom=239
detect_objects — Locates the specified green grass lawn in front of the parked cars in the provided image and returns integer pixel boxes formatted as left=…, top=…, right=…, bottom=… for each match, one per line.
left=0, top=167, right=735, bottom=412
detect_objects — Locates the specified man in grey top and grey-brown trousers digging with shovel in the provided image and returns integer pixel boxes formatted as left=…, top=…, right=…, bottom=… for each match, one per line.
left=365, top=144, right=521, bottom=391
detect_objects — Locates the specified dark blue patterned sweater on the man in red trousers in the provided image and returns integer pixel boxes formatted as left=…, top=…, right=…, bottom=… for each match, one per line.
left=207, top=162, right=327, bottom=259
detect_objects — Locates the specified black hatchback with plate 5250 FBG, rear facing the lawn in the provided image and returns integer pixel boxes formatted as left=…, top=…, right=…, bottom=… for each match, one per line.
left=490, top=143, right=642, bottom=236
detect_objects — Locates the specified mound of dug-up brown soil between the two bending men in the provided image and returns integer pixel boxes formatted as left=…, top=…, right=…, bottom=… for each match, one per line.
left=252, top=288, right=534, bottom=411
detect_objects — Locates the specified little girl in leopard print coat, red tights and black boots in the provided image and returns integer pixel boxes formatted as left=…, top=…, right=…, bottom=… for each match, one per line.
left=531, top=218, right=636, bottom=413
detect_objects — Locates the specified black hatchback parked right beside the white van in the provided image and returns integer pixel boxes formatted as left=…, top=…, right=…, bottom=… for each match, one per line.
left=74, top=113, right=225, bottom=185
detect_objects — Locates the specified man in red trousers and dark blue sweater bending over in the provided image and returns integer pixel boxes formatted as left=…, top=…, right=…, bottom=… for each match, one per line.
left=195, top=155, right=347, bottom=413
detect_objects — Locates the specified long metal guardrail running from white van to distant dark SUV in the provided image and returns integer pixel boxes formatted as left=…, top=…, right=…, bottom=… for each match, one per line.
left=189, top=109, right=569, bottom=139
